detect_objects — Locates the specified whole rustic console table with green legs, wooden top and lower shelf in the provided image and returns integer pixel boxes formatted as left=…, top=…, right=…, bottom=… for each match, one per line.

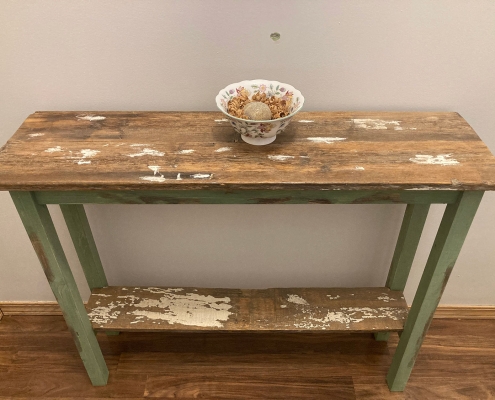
left=0, top=112, right=495, bottom=391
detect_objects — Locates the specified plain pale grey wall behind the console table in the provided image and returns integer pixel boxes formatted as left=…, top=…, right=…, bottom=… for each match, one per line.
left=0, top=0, right=495, bottom=305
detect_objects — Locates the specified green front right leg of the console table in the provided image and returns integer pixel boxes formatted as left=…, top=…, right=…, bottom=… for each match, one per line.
left=387, top=191, right=483, bottom=391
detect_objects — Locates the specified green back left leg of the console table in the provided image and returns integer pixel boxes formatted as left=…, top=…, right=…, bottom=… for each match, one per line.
left=60, top=204, right=119, bottom=336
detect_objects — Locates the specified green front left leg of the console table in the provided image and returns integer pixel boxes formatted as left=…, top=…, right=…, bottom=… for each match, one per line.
left=11, top=192, right=108, bottom=386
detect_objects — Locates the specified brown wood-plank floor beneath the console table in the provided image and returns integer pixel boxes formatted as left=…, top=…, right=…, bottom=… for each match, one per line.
left=0, top=316, right=495, bottom=400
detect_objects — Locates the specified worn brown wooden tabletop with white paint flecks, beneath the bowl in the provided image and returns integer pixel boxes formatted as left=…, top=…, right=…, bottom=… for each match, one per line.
left=0, top=112, right=495, bottom=191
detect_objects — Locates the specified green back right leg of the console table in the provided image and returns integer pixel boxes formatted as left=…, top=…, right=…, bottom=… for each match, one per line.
left=375, top=204, right=430, bottom=341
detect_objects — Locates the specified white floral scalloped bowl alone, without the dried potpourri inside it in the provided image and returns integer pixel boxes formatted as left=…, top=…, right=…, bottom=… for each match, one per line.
left=215, top=79, right=304, bottom=145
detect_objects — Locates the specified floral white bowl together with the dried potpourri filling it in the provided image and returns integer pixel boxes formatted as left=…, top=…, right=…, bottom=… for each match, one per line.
left=215, top=79, right=304, bottom=145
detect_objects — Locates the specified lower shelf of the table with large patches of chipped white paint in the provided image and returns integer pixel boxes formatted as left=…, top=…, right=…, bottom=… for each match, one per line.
left=86, top=286, right=408, bottom=332
